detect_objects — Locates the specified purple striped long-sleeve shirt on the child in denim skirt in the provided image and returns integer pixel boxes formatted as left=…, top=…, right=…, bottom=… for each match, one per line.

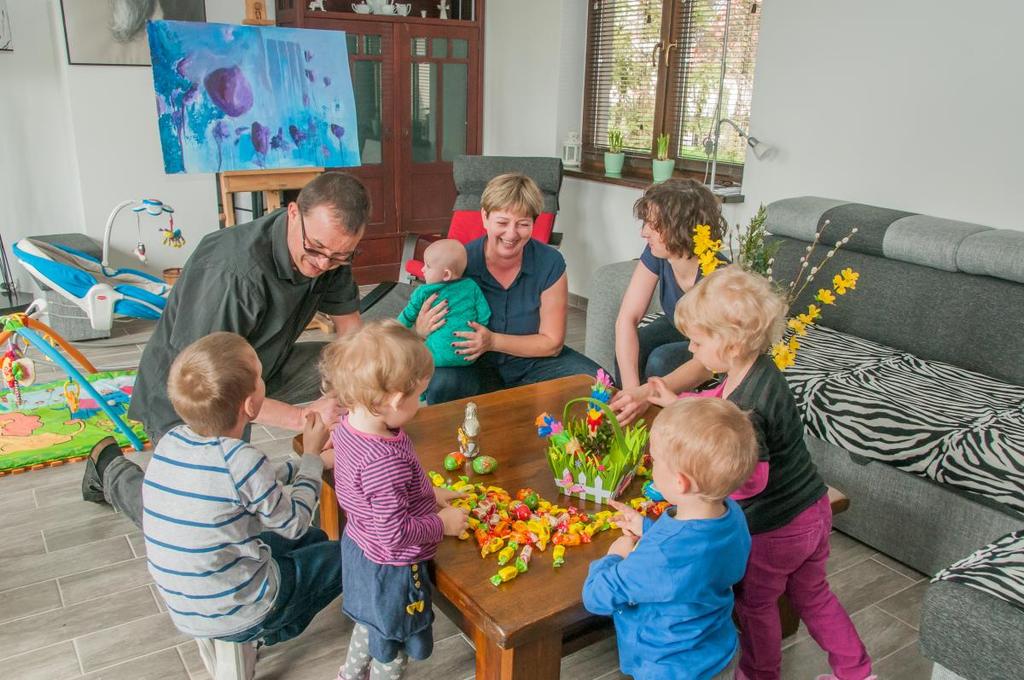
left=331, top=417, right=444, bottom=566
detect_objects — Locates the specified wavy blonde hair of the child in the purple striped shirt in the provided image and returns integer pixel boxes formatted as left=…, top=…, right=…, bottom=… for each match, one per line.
left=319, top=318, right=434, bottom=414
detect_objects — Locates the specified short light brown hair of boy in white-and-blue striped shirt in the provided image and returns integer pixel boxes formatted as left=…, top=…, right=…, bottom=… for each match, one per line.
left=167, top=332, right=259, bottom=436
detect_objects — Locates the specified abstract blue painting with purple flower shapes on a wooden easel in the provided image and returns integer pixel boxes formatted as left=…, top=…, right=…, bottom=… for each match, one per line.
left=148, top=22, right=359, bottom=174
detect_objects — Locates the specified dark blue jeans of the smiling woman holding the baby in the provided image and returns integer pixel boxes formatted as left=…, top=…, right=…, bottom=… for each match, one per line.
left=425, top=347, right=600, bottom=403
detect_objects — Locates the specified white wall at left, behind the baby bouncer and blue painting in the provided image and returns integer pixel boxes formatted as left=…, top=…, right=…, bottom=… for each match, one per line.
left=0, top=0, right=272, bottom=292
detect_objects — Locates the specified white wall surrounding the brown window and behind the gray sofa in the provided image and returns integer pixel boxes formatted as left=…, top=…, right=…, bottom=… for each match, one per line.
left=483, top=0, right=1024, bottom=296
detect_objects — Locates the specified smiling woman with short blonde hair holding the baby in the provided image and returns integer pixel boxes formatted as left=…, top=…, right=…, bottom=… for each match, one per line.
left=416, top=173, right=598, bottom=403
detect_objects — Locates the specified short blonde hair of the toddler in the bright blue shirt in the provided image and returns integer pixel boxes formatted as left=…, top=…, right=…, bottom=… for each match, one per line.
left=650, top=397, right=758, bottom=501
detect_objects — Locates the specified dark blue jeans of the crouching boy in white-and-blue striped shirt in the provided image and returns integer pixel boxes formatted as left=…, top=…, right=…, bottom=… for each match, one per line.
left=220, top=526, right=341, bottom=644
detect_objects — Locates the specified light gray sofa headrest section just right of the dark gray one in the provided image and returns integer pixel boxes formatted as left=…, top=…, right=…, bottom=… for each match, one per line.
left=882, top=215, right=991, bottom=271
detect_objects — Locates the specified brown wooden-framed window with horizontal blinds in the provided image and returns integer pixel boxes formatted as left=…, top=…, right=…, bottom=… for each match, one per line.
left=584, top=0, right=761, bottom=176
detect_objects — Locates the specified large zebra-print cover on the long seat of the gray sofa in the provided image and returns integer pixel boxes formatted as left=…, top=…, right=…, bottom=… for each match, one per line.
left=785, top=327, right=1024, bottom=512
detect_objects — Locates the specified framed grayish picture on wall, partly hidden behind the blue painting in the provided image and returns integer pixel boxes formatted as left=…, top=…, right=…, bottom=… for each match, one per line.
left=60, top=0, right=206, bottom=67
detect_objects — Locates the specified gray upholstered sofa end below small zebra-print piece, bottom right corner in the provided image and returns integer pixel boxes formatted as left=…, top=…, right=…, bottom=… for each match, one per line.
left=921, top=569, right=1024, bottom=680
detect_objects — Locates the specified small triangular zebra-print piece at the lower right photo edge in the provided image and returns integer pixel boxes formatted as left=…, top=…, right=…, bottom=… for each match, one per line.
left=932, top=530, right=1024, bottom=609
